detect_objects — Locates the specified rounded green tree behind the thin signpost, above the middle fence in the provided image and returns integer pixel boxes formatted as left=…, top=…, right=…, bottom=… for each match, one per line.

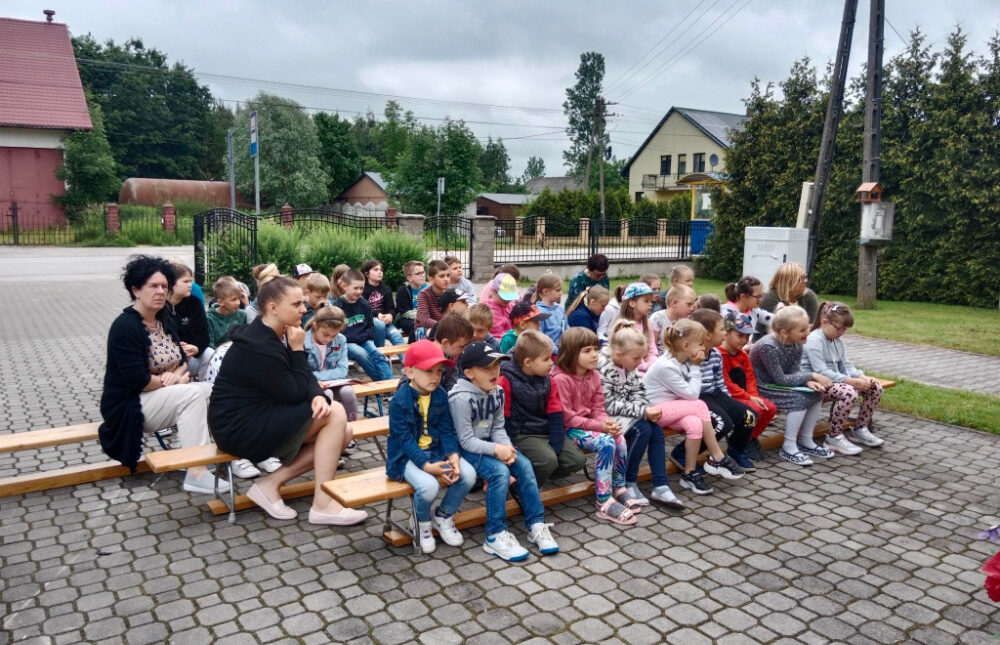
left=389, top=119, right=482, bottom=215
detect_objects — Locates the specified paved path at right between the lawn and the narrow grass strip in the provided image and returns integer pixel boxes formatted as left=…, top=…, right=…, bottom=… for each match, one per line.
left=844, top=334, right=1000, bottom=396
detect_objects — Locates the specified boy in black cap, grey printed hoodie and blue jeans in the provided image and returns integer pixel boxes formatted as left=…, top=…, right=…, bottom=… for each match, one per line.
left=448, top=341, right=559, bottom=562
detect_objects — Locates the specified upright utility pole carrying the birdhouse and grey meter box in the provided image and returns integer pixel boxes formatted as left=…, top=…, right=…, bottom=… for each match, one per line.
left=858, top=0, right=885, bottom=309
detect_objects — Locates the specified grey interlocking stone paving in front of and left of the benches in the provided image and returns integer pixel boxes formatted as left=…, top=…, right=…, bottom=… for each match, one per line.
left=0, top=248, right=1000, bottom=645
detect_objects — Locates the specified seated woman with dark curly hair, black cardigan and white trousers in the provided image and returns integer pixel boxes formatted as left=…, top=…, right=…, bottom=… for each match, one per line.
left=100, top=255, right=223, bottom=494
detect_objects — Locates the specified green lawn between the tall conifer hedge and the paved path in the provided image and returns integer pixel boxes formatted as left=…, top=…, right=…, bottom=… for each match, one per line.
left=592, top=278, right=1000, bottom=356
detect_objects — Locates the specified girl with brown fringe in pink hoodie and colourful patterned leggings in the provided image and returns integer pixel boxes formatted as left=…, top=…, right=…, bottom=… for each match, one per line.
left=552, top=327, right=639, bottom=526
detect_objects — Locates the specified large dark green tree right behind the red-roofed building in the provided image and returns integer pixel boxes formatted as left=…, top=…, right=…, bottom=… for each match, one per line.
left=73, top=34, right=225, bottom=179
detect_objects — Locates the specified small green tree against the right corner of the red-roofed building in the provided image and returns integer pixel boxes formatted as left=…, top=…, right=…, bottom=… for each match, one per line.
left=55, top=95, right=121, bottom=221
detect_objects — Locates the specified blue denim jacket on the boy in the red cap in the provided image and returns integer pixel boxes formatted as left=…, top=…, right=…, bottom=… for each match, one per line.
left=385, top=383, right=458, bottom=481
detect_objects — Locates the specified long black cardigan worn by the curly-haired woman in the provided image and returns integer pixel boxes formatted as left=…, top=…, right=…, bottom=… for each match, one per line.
left=98, top=306, right=187, bottom=472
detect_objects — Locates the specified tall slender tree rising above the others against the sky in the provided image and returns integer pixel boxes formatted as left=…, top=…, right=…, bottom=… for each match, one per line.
left=563, top=52, right=608, bottom=176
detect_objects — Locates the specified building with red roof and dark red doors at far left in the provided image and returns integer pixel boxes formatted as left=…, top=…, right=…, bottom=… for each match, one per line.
left=0, top=11, right=92, bottom=231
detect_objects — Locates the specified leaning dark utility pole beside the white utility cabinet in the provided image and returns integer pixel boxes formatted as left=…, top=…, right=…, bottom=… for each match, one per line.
left=806, top=0, right=856, bottom=273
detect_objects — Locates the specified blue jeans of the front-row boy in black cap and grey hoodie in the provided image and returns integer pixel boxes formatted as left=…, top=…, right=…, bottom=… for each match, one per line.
left=462, top=450, right=545, bottom=537
